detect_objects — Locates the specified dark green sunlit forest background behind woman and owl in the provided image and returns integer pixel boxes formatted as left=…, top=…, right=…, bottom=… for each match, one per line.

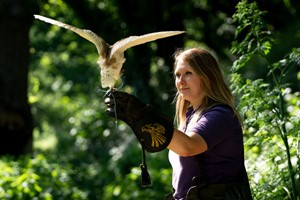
left=0, top=0, right=300, bottom=200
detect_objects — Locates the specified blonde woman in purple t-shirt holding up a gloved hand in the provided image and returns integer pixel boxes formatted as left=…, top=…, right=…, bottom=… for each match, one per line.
left=105, top=48, right=252, bottom=200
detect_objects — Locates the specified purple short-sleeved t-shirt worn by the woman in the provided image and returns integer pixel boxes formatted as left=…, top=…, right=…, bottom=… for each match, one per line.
left=169, top=106, right=244, bottom=200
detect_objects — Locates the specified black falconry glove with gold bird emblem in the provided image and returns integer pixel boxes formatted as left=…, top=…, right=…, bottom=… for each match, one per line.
left=104, top=91, right=174, bottom=152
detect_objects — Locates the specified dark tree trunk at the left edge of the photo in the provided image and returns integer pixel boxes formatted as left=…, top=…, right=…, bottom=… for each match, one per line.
left=0, top=0, right=34, bottom=156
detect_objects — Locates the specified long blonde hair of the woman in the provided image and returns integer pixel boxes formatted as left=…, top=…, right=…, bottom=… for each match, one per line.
left=174, top=48, right=241, bottom=128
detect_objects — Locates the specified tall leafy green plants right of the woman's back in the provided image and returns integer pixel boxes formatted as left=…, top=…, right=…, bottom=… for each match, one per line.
left=232, top=1, right=300, bottom=200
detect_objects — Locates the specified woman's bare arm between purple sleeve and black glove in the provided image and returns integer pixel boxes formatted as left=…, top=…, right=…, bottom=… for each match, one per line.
left=168, top=129, right=207, bottom=156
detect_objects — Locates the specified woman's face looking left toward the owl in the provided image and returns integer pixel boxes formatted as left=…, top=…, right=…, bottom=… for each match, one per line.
left=174, top=58, right=205, bottom=109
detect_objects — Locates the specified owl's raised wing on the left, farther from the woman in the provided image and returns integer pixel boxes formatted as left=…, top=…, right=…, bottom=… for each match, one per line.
left=34, top=15, right=109, bottom=58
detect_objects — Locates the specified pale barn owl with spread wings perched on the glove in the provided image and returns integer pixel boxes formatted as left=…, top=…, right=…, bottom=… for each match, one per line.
left=34, top=15, right=184, bottom=89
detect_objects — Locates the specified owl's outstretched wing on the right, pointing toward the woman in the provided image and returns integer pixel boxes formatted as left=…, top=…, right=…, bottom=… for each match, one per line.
left=109, top=31, right=185, bottom=59
